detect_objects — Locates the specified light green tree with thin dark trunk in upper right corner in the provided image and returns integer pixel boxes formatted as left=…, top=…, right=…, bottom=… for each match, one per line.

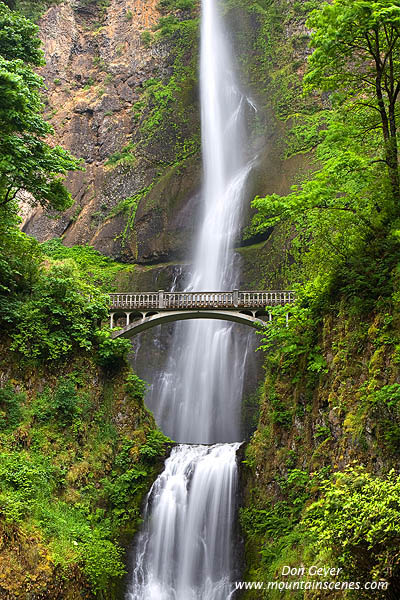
left=304, top=0, right=400, bottom=204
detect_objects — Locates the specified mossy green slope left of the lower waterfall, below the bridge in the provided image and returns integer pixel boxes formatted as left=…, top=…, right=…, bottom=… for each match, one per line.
left=0, top=343, right=170, bottom=600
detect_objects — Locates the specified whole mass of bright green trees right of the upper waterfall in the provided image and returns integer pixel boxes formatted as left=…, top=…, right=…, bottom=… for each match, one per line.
left=253, top=0, right=400, bottom=299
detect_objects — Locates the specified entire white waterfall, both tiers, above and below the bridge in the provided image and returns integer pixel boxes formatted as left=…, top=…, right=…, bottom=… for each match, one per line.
left=126, top=0, right=252, bottom=600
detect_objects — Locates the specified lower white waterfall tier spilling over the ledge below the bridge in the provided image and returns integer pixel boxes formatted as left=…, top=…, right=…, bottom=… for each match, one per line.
left=126, top=444, right=240, bottom=600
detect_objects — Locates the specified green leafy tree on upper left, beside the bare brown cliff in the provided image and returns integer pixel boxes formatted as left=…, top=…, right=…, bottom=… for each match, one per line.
left=0, top=2, right=80, bottom=210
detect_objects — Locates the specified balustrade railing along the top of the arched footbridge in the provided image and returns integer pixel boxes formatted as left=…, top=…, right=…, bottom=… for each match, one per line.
left=110, top=290, right=295, bottom=310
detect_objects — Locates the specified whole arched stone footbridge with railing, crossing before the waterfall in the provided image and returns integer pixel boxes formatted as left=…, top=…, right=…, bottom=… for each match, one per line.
left=110, top=290, right=294, bottom=338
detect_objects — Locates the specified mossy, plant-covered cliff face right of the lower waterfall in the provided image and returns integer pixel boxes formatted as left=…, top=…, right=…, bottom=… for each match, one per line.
left=240, top=290, right=400, bottom=600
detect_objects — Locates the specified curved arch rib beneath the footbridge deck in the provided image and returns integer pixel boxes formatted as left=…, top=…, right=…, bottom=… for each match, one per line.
left=112, top=309, right=265, bottom=338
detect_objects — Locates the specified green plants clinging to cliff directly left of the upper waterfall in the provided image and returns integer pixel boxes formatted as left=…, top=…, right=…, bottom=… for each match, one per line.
left=103, top=1, right=200, bottom=245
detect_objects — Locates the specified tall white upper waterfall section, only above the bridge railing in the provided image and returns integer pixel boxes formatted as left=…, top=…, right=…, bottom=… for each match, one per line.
left=194, top=0, right=251, bottom=291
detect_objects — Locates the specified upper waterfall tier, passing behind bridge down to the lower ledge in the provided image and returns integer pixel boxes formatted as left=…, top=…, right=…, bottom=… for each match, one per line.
left=147, top=0, right=253, bottom=443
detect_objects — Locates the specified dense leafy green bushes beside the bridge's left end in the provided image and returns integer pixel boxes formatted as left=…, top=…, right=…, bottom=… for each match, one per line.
left=0, top=233, right=134, bottom=370
